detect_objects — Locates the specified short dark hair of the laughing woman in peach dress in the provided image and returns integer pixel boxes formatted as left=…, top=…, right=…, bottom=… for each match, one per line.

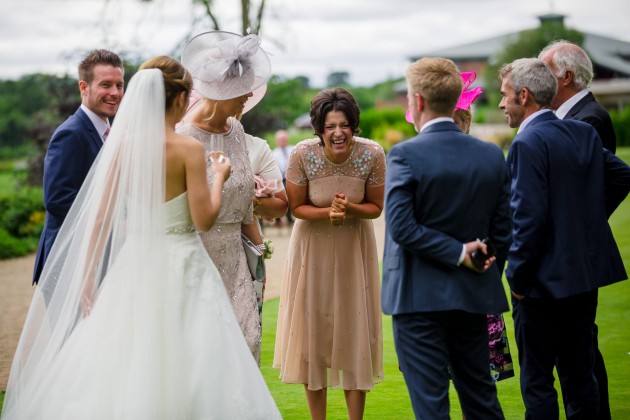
left=310, top=88, right=361, bottom=146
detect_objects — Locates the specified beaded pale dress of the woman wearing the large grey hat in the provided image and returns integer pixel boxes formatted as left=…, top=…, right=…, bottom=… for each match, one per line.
left=177, top=118, right=262, bottom=363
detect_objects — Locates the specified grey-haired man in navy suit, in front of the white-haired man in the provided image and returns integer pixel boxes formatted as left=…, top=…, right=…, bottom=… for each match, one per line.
left=499, top=59, right=630, bottom=420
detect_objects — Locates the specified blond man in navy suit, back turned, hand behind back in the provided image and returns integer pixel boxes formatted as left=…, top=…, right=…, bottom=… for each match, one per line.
left=382, top=58, right=510, bottom=420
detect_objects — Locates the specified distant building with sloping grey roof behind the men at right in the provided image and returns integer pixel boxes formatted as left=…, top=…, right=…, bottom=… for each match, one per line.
left=411, top=14, right=630, bottom=108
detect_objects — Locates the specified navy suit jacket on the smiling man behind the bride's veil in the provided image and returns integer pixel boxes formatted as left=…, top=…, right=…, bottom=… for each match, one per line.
left=33, top=108, right=103, bottom=283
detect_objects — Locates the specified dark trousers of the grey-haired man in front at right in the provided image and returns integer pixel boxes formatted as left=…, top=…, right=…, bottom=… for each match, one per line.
left=512, top=290, right=599, bottom=420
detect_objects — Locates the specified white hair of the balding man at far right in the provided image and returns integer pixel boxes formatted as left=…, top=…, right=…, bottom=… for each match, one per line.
left=538, top=39, right=593, bottom=90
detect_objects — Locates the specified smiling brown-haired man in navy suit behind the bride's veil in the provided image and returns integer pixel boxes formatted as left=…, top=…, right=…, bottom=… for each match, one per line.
left=33, top=50, right=124, bottom=284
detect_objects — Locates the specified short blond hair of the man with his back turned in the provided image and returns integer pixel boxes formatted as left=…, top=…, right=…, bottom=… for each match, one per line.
left=405, top=57, right=464, bottom=115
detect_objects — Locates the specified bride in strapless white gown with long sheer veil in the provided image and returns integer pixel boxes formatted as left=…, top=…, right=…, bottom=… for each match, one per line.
left=2, top=57, right=280, bottom=420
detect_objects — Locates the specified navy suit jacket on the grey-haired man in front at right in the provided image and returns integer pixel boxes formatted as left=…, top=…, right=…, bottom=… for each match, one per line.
left=506, top=112, right=630, bottom=299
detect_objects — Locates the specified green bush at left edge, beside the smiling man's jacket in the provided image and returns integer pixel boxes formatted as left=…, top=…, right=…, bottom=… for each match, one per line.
left=0, top=187, right=46, bottom=259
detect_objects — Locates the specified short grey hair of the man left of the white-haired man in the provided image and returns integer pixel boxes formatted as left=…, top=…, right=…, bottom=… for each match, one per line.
left=499, top=58, right=558, bottom=106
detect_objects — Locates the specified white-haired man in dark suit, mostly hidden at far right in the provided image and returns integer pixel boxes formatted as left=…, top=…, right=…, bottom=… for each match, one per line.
left=538, top=41, right=617, bottom=420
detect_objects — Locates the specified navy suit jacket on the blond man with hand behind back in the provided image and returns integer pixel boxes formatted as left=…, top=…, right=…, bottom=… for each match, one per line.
left=382, top=122, right=511, bottom=315
